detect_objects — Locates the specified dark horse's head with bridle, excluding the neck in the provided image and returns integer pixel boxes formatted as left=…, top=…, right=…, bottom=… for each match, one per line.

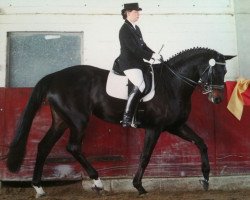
left=199, top=53, right=235, bottom=104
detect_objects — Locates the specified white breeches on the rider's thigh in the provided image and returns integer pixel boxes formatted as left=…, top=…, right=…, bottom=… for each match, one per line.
left=124, top=69, right=145, bottom=92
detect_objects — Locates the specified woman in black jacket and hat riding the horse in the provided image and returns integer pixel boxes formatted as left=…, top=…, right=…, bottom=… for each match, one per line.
left=118, top=3, right=161, bottom=127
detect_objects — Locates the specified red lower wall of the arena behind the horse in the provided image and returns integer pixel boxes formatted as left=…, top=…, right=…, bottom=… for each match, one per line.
left=0, top=88, right=250, bottom=180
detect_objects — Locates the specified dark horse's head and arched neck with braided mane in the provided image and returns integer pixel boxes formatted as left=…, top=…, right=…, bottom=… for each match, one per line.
left=164, top=47, right=235, bottom=104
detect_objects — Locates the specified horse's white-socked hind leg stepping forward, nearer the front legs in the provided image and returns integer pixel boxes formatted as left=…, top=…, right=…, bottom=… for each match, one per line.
left=67, top=118, right=103, bottom=192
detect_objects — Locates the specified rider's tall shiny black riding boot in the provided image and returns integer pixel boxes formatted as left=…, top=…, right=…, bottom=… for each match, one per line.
left=122, top=86, right=142, bottom=127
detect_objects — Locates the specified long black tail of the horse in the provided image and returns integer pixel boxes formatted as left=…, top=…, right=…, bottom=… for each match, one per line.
left=7, top=75, right=51, bottom=172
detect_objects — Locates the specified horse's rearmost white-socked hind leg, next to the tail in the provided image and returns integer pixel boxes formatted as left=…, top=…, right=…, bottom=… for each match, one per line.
left=32, top=113, right=66, bottom=198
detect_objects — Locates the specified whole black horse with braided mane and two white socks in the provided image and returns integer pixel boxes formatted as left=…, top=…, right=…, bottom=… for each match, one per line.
left=7, top=48, right=234, bottom=196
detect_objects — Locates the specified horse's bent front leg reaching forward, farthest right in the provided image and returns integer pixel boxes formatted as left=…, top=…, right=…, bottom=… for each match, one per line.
left=169, top=124, right=210, bottom=190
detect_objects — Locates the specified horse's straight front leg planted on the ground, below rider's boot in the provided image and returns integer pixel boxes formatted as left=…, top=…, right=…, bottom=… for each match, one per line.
left=133, top=129, right=160, bottom=195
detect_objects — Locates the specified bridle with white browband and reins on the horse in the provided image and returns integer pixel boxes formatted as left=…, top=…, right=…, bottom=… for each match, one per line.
left=165, top=58, right=226, bottom=94
